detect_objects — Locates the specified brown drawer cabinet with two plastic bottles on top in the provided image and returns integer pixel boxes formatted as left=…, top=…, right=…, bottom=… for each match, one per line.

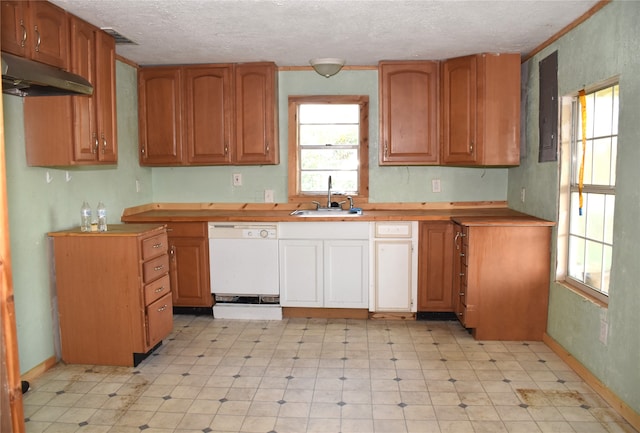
left=49, top=224, right=173, bottom=366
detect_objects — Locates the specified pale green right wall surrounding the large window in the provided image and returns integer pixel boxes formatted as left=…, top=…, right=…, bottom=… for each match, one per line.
left=508, top=1, right=640, bottom=413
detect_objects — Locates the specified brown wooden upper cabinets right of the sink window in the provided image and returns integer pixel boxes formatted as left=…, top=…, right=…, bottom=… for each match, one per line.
left=379, top=54, right=520, bottom=166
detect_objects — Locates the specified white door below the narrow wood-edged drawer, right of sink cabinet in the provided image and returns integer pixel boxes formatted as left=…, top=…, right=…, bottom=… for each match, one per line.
left=373, top=239, right=413, bottom=312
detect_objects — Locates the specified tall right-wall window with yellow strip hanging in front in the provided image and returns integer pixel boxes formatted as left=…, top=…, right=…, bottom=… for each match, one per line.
left=562, top=84, right=619, bottom=303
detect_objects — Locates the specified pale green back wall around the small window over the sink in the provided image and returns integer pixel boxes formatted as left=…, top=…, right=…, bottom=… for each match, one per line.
left=153, top=70, right=507, bottom=204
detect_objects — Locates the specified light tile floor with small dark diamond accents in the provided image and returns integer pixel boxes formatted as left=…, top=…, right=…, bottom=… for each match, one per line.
left=24, top=315, right=635, bottom=433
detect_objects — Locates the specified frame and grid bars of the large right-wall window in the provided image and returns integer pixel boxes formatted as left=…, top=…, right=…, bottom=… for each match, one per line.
left=556, top=77, right=620, bottom=307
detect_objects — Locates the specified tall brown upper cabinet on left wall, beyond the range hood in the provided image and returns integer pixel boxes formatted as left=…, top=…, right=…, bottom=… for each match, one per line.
left=24, top=11, right=118, bottom=167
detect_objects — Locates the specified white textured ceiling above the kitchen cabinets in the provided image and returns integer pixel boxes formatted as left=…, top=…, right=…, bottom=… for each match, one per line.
left=52, top=0, right=597, bottom=66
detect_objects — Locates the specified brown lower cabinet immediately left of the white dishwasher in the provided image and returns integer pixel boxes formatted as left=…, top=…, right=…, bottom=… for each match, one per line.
left=167, top=222, right=213, bottom=307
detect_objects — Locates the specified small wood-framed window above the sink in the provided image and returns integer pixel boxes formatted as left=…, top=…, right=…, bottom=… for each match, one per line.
left=288, top=96, right=369, bottom=202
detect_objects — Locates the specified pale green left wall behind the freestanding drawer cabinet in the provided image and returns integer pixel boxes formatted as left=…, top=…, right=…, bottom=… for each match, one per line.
left=3, top=62, right=153, bottom=372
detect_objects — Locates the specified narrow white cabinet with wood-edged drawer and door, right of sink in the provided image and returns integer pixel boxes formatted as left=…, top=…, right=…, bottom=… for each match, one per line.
left=370, top=221, right=418, bottom=312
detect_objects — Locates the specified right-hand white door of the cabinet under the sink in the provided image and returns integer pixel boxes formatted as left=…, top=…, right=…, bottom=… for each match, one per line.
left=324, top=240, right=369, bottom=308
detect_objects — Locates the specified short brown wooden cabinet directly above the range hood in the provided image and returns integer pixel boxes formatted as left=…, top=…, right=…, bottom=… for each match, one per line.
left=2, top=0, right=69, bottom=69
